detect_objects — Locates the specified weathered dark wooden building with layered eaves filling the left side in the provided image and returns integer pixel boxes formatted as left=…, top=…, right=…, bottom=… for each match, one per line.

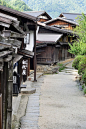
left=0, top=5, right=37, bottom=129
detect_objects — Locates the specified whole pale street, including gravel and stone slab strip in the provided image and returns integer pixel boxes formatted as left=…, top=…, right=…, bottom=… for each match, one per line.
left=21, top=63, right=86, bottom=129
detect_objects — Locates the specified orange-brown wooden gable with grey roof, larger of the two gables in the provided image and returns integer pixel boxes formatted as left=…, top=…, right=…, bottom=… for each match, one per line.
left=45, top=17, right=78, bottom=30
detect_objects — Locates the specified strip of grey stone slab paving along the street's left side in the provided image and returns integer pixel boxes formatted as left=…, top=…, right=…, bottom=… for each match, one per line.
left=20, top=77, right=43, bottom=129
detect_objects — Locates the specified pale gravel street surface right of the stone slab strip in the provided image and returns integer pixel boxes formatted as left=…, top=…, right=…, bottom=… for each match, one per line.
left=38, top=64, right=86, bottom=129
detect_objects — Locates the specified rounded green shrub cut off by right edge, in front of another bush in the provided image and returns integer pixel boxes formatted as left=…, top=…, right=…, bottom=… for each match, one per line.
left=78, top=56, right=86, bottom=74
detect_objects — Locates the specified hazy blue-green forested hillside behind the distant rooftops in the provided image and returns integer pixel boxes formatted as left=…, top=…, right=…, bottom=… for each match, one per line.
left=23, top=0, right=86, bottom=18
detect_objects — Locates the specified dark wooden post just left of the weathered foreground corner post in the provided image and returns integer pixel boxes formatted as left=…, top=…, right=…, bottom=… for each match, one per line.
left=0, top=58, right=7, bottom=129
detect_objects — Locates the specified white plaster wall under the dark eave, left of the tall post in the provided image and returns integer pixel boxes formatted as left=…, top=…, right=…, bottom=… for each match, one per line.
left=25, top=31, right=34, bottom=51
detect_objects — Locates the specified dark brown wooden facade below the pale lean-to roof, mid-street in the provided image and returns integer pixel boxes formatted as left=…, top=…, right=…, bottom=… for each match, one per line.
left=37, top=44, right=73, bottom=64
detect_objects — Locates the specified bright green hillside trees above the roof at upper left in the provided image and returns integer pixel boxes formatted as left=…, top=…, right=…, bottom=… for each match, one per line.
left=0, top=0, right=31, bottom=11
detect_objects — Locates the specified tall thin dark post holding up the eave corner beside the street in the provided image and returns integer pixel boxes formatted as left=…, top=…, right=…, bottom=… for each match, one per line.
left=34, top=25, right=37, bottom=81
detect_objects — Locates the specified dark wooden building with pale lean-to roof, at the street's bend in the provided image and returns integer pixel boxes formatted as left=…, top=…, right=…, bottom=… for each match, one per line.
left=36, top=23, right=76, bottom=64
